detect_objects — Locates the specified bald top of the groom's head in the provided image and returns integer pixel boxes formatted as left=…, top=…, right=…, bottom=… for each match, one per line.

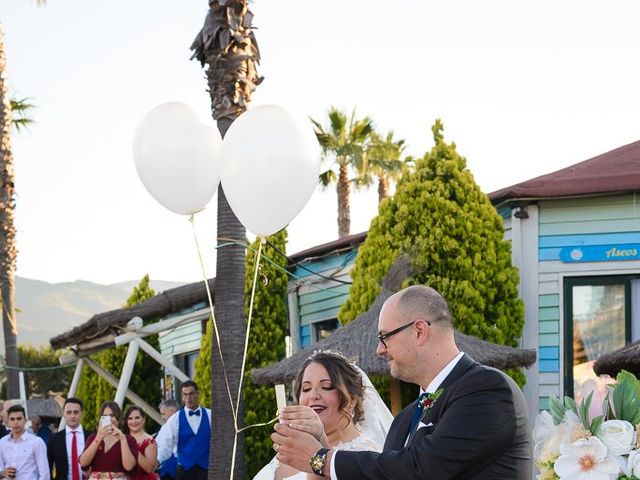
left=394, top=285, right=453, bottom=329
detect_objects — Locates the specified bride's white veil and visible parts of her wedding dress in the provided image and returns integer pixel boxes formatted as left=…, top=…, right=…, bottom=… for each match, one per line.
left=253, top=365, right=393, bottom=480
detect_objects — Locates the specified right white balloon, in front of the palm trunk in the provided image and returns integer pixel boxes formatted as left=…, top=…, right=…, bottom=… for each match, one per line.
left=221, top=105, right=320, bottom=236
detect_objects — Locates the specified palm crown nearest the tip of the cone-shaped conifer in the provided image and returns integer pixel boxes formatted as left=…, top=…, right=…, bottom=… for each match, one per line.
left=356, top=130, right=408, bottom=204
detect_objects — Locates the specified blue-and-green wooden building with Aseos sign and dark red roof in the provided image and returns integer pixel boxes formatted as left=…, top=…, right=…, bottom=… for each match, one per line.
left=489, top=142, right=640, bottom=418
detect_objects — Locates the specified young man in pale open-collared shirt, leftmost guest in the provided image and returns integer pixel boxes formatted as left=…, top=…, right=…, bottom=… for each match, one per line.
left=0, top=405, right=50, bottom=480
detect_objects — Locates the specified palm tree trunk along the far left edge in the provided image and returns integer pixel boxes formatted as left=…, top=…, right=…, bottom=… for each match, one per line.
left=0, top=28, right=19, bottom=398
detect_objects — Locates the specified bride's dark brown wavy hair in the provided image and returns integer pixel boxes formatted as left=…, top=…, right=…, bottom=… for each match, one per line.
left=292, top=351, right=364, bottom=424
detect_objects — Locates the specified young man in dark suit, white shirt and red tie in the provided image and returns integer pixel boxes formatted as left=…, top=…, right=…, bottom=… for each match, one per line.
left=47, top=397, right=90, bottom=480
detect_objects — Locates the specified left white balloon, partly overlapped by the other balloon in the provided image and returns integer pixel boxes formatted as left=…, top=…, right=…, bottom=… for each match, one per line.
left=133, top=102, right=222, bottom=215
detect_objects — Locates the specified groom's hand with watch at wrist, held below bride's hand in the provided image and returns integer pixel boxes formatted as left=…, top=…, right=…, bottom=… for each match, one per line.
left=271, top=423, right=322, bottom=473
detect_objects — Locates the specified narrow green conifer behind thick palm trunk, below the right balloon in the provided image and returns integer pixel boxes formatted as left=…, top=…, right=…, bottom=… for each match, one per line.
left=194, top=230, right=289, bottom=478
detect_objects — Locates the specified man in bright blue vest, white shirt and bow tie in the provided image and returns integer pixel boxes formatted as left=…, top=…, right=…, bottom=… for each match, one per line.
left=156, top=380, right=211, bottom=480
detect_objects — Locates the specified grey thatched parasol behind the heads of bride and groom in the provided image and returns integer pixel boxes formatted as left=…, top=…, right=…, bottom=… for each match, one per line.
left=251, top=257, right=536, bottom=385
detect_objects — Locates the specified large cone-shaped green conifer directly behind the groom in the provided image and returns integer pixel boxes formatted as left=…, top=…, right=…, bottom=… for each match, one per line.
left=339, top=120, right=524, bottom=381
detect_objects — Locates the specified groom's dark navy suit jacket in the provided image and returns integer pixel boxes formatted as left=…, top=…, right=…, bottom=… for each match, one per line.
left=335, top=354, right=532, bottom=480
